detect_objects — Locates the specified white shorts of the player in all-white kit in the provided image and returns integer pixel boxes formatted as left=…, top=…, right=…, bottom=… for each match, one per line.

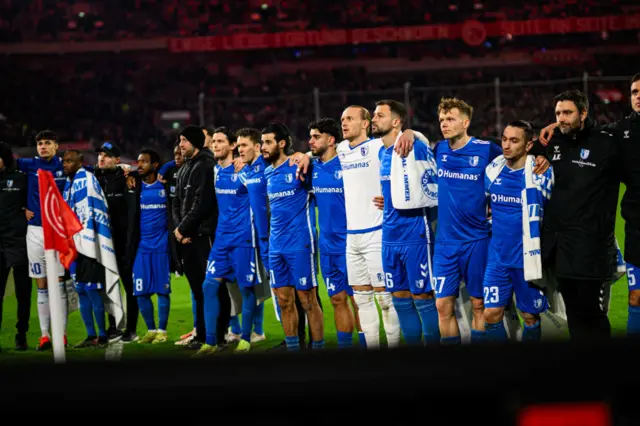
left=347, top=229, right=384, bottom=287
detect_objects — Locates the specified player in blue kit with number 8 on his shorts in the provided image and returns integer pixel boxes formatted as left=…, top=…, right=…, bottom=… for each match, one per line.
left=126, top=149, right=171, bottom=344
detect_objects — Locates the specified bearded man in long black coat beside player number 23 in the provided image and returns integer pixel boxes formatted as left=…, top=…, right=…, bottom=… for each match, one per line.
left=542, top=90, right=625, bottom=340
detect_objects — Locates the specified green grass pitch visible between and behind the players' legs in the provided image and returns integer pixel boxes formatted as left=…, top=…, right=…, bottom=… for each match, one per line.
left=0, top=188, right=628, bottom=363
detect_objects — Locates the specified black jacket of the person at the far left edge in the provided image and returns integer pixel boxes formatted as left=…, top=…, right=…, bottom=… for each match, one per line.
left=0, top=168, right=28, bottom=266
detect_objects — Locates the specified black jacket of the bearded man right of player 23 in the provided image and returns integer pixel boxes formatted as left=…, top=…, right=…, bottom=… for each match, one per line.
left=542, top=119, right=620, bottom=281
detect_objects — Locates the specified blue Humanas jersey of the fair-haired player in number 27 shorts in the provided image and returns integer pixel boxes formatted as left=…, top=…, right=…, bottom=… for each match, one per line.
left=434, top=137, right=502, bottom=244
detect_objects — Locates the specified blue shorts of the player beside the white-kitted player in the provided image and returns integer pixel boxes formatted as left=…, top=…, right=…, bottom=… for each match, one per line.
left=382, top=243, right=433, bottom=294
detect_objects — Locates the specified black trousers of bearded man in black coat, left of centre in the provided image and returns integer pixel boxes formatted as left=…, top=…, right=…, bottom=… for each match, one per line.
left=179, top=235, right=231, bottom=342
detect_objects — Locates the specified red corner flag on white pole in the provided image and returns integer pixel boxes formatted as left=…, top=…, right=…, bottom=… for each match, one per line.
left=38, top=169, right=82, bottom=269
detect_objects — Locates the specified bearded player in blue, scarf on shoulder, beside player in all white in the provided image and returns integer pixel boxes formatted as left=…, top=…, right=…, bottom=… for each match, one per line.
left=372, top=100, right=440, bottom=345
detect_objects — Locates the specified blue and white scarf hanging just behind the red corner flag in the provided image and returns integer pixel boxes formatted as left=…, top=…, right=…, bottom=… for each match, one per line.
left=64, top=168, right=124, bottom=328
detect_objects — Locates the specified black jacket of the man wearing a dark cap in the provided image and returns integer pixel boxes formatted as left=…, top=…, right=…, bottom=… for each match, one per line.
left=94, top=167, right=128, bottom=264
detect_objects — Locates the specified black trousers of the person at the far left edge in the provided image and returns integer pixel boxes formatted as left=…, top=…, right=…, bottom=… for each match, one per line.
left=0, top=253, right=33, bottom=334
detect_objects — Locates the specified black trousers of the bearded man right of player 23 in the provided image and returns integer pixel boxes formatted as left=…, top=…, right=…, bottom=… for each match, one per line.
left=558, top=278, right=611, bottom=340
